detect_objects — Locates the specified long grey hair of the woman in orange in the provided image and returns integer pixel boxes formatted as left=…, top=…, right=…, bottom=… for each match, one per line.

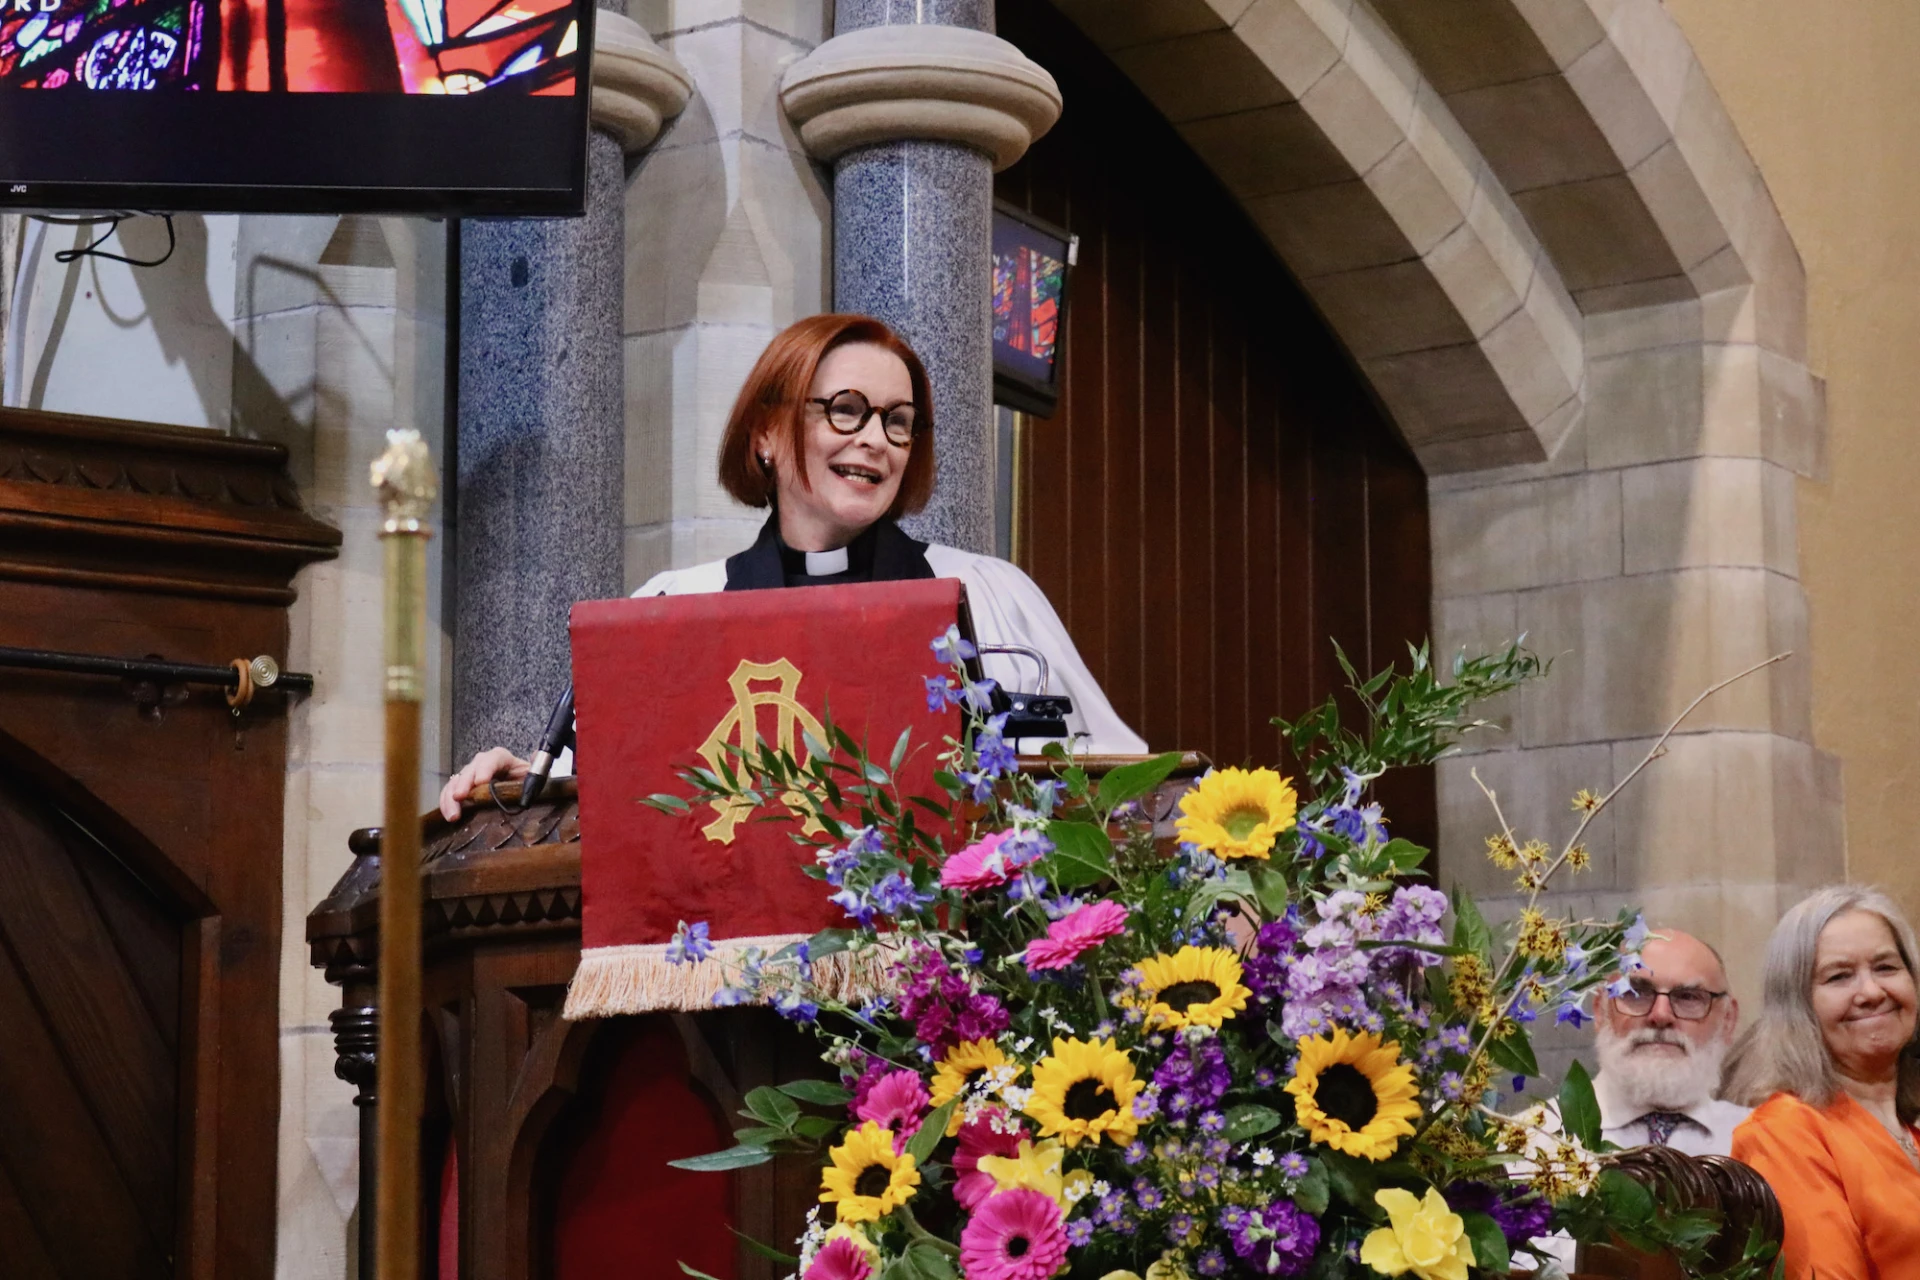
left=1720, top=885, right=1920, bottom=1125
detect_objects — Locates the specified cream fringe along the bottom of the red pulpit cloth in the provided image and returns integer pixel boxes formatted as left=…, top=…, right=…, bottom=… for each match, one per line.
left=561, top=933, right=895, bottom=1021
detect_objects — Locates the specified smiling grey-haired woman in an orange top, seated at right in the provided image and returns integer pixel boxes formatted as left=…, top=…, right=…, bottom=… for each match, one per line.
left=1722, top=885, right=1920, bottom=1280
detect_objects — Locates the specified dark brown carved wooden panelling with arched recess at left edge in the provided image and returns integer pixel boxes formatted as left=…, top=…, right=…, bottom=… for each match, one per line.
left=0, top=409, right=340, bottom=1280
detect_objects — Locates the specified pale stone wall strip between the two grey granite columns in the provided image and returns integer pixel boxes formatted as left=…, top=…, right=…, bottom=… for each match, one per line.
left=626, top=0, right=831, bottom=589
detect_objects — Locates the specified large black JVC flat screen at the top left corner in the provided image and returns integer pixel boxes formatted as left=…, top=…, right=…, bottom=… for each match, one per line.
left=0, top=0, right=593, bottom=215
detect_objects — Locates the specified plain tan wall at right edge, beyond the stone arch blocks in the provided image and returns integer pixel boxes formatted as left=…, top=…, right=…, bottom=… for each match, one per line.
left=1668, top=0, right=1920, bottom=913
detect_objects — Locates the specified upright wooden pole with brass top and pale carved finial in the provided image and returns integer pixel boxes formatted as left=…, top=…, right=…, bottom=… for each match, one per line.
left=363, top=430, right=440, bottom=1280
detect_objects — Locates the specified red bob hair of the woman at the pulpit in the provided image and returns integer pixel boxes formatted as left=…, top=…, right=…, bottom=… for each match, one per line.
left=720, top=313, right=933, bottom=516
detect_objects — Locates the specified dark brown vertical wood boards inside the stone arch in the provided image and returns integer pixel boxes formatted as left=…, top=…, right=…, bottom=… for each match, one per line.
left=996, top=2, right=1432, bottom=842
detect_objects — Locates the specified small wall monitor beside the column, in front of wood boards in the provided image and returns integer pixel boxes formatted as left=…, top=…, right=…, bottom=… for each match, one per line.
left=993, top=203, right=1079, bottom=418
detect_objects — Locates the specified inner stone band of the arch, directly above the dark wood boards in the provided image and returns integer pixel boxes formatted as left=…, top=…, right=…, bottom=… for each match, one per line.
left=1060, top=0, right=1584, bottom=474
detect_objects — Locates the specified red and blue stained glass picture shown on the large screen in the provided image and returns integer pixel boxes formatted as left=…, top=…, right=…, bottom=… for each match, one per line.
left=0, top=0, right=580, bottom=96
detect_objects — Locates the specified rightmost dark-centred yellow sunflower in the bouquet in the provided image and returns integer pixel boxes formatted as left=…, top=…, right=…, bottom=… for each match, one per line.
left=1286, top=1031, right=1421, bottom=1159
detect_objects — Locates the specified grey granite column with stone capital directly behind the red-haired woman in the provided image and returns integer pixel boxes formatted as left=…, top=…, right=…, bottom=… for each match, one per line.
left=781, top=0, right=1060, bottom=553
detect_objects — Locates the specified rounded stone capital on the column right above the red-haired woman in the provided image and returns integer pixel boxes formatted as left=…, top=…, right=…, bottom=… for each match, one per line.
left=780, top=25, right=1060, bottom=169
